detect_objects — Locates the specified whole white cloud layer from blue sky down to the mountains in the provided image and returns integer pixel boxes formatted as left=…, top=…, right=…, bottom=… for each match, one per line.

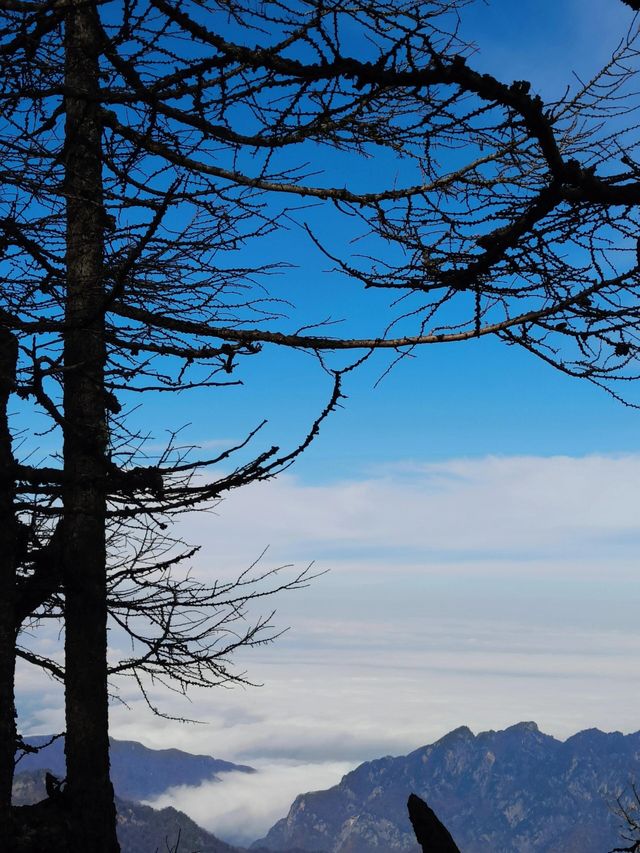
left=13, top=455, right=640, bottom=835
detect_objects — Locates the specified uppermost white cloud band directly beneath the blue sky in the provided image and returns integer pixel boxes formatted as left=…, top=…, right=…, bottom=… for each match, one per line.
left=183, top=456, right=640, bottom=574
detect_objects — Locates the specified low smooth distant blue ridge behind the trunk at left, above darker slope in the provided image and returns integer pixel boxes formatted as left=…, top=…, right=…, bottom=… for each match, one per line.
left=17, top=736, right=255, bottom=800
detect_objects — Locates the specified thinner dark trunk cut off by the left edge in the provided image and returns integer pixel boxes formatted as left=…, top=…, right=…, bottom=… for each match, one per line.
left=0, top=328, right=18, bottom=841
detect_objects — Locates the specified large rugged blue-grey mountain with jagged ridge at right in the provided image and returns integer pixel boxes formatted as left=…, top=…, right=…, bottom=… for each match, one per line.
left=253, top=723, right=640, bottom=853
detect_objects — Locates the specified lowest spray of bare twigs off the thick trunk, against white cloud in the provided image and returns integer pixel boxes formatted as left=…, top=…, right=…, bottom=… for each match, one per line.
left=16, top=519, right=317, bottom=708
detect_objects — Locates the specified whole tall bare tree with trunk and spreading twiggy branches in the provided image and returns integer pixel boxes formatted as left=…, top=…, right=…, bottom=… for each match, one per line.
left=0, top=0, right=640, bottom=853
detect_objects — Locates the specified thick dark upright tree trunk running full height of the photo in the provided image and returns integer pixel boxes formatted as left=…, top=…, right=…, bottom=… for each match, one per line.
left=63, top=0, right=120, bottom=853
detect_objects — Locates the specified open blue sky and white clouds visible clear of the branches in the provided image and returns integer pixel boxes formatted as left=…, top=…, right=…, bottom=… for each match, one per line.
left=16, top=0, right=640, bottom=841
